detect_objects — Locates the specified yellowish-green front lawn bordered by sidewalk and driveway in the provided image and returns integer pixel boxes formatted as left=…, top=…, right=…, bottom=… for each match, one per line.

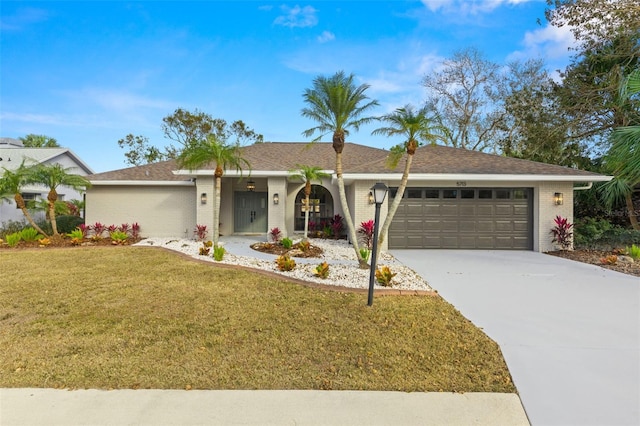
left=0, top=247, right=515, bottom=392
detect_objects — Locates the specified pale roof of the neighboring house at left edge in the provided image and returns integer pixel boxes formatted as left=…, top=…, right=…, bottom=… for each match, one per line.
left=0, top=138, right=93, bottom=174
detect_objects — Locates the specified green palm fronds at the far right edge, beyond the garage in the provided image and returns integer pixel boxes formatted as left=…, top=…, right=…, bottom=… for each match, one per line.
left=599, top=69, right=640, bottom=230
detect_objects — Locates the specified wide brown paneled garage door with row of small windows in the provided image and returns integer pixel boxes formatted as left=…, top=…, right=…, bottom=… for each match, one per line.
left=389, top=188, right=533, bottom=250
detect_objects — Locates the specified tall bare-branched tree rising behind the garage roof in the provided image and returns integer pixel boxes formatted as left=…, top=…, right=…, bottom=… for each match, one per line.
left=422, top=48, right=505, bottom=151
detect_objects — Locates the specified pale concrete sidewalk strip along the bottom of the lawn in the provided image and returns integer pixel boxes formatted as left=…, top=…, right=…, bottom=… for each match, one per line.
left=0, top=389, right=529, bottom=426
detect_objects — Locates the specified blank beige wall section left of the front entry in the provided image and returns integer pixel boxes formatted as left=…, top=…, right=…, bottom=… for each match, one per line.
left=85, top=185, right=200, bottom=238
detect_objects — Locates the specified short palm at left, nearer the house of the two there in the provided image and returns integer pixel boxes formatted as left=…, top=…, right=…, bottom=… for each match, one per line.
left=27, top=163, right=91, bottom=236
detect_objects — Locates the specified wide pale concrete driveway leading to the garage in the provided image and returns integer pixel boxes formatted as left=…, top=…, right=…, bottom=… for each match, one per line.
left=391, top=250, right=640, bottom=426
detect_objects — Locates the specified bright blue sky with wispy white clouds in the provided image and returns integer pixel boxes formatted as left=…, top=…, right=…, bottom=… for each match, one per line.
left=0, top=0, right=572, bottom=172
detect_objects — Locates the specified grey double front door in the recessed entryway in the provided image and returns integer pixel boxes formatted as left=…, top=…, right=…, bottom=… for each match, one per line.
left=233, top=191, right=268, bottom=234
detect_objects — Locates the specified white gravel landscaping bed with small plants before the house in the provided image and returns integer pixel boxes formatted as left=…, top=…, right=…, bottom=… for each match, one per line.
left=136, top=238, right=431, bottom=291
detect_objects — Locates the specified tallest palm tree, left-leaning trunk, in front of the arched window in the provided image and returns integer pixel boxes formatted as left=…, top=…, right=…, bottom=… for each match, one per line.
left=302, top=71, right=378, bottom=268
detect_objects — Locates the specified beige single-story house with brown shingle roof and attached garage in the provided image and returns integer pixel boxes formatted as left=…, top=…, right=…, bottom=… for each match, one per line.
left=86, top=142, right=610, bottom=251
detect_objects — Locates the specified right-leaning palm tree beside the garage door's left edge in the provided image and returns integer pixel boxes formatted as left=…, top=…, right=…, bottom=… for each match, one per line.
left=372, top=105, right=448, bottom=256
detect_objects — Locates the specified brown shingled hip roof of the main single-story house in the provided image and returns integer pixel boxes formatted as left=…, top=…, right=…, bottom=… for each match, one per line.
left=89, top=142, right=610, bottom=184
